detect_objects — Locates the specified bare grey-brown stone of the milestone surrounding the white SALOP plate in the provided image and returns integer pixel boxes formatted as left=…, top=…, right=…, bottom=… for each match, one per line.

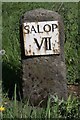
left=20, top=9, right=67, bottom=105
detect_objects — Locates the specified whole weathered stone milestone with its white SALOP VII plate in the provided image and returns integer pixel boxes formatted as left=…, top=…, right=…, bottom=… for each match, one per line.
left=20, top=8, right=67, bottom=106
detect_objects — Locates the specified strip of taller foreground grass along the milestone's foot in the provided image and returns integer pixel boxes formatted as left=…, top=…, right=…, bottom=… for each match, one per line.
left=3, top=85, right=80, bottom=120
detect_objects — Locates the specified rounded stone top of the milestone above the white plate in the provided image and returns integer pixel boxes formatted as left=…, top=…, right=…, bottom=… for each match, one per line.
left=21, top=8, right=61, bottom=23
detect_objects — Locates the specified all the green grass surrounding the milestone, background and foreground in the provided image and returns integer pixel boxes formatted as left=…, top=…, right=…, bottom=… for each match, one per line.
left=1, top=2, right=80, bottom=119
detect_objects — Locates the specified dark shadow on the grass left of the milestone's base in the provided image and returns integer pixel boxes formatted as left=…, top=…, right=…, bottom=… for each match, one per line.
left=2, top=62, right=23, bottom=100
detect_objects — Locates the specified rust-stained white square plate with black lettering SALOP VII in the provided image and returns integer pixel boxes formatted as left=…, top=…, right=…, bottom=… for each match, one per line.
left=23, top=21, right=60, bottom=56
